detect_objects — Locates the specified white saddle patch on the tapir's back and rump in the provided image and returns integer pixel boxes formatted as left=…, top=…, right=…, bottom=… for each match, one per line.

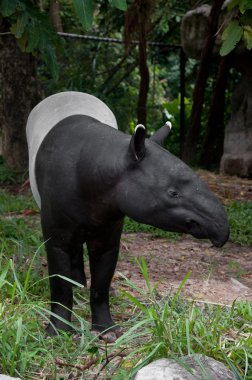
left=26, top=91, right=117, bottom=207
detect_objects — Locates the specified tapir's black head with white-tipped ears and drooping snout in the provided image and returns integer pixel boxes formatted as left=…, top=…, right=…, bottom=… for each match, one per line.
left=118, top=123, right=229, bottom=247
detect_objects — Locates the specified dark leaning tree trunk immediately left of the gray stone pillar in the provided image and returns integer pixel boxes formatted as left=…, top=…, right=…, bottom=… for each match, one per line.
left=201, top=56, right=230, bottom=169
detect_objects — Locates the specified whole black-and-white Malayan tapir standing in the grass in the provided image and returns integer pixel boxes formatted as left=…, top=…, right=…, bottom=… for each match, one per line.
left=27, top=92, right=229, bottom=341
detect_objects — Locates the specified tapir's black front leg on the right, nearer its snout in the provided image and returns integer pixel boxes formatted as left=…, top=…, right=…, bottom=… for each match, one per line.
left=87, top=221, right=123, bottom=342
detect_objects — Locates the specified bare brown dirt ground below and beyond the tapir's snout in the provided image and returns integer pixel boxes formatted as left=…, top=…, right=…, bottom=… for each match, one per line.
left=114, top=171, right=252, bottom=305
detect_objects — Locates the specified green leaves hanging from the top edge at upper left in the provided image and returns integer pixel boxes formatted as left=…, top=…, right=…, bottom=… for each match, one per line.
left=0, top=0, right=127, bottom=78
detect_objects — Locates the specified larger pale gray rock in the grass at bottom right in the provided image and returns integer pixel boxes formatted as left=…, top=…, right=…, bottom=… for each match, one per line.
left=135, top=355, right=236, bottom=380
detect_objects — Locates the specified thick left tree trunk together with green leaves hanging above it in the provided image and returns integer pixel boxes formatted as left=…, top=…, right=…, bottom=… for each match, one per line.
left=0, top=0, right=127, bottom=172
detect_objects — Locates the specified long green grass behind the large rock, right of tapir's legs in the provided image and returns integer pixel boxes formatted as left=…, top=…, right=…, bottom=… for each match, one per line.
left=113, top=259, right=252, bottom=379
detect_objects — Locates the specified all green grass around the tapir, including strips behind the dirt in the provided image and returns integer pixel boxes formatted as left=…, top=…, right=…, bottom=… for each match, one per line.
left=0, top=192, right=252, bottom=380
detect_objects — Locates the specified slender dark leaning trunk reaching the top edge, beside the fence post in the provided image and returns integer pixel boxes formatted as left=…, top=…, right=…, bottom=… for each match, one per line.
left=182, top=0, right=224, bottom=163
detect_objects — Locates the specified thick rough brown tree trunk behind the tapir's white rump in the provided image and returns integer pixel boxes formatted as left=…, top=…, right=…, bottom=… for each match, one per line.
left=0, top=20, right=41, bottom=173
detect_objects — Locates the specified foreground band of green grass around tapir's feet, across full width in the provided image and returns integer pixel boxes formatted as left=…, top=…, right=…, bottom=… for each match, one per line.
left=0, top=252, right=252, bottom=380
